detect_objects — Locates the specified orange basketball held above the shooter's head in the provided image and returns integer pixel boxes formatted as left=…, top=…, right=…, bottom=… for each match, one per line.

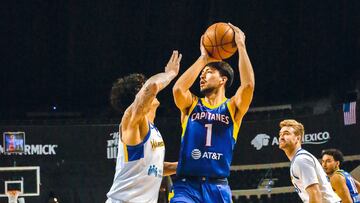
left=203, top=23, right=237, bottom=60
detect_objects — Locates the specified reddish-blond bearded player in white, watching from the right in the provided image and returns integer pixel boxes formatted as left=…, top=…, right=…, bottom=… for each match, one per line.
left=279, top=120, right=341, bottom=203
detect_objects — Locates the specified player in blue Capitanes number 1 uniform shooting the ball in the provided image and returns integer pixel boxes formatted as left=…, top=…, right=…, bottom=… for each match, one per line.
left=171, top=25, right=255, bottom=203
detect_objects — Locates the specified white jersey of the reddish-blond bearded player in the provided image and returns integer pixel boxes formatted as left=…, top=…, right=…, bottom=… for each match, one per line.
left=290, top=148, right=341, bottom=203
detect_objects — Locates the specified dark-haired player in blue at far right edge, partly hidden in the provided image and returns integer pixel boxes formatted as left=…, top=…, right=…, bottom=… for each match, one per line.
left=321, top=149, right=360, bottom=203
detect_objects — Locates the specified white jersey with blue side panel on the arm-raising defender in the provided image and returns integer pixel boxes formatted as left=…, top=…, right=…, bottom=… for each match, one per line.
left=107, top=124, right=165, bottom=203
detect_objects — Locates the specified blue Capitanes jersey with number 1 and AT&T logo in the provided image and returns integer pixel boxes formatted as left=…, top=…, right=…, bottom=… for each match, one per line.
left=177, top=98, right=240, bottom=178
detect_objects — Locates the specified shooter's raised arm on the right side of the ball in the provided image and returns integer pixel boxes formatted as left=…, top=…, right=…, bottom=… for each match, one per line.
left=229, top=23, right=255, bottom=121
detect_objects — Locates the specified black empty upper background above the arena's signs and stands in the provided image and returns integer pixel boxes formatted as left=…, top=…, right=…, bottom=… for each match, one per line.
left=0, top=0, right=360, bottom=119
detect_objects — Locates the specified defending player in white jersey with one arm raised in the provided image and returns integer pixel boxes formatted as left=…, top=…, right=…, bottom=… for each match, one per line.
left=106, top=51, right=182, bottom=203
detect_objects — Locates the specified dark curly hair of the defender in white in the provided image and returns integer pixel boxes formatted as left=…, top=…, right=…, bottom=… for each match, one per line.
left=110, top=73, right=146, bottom=113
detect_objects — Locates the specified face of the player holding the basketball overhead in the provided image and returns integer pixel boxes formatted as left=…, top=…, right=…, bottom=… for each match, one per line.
left=200, top=66, right=224, bottom=94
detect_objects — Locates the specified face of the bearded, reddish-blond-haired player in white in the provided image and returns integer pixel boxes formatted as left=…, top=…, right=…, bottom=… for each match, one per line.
left=279, top=126, right=300, bottom=149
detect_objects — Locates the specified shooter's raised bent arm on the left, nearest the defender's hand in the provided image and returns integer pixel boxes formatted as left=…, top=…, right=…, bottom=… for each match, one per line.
left=173, top=36, right=216, bottom=114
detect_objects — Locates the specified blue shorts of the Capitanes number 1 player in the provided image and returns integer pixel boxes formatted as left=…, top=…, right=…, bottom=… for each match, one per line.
left=170, top=177, right=232, bottom=203
